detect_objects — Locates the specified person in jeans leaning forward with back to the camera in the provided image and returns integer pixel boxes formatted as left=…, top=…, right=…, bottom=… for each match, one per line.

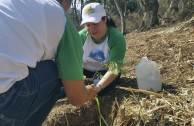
left=0, top=0, right=97, bottom=126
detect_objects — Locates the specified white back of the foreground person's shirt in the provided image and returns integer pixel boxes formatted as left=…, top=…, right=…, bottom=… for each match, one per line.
left=0, top=0, right=66, bottom=93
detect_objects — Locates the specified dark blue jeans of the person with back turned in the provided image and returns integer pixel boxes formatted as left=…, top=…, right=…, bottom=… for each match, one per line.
left=0, top=60, right=62, bottom=126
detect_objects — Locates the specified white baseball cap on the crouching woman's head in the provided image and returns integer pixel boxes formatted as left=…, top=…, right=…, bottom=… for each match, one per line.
left=81, top=2, right=106, bottom=25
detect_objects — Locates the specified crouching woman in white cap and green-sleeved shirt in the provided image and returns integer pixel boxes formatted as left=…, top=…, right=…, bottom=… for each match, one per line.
left=79, top=2, right=126, bottom=96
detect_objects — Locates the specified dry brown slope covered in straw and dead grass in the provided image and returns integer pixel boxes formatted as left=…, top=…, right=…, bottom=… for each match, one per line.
left=43, top=17, right=194, bottom=126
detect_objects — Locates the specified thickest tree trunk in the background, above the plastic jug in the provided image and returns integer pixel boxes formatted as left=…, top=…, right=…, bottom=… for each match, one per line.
left=142, top=0, right=159, bottom=30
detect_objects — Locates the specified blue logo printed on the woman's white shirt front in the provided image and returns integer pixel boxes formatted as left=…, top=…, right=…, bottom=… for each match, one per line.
left=88, top=49, right=105, bottom=62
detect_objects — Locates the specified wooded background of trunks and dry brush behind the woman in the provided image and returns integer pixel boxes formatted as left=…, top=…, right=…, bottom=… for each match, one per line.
left=69, top=0, right=194, bottom=34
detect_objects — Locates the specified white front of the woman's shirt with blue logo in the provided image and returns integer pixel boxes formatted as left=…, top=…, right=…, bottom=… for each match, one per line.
left=83, top=35, right=110, bottom=72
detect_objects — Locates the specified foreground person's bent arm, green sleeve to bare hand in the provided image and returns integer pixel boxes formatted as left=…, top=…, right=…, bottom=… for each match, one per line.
left=56, top=15, right=97, bottom=105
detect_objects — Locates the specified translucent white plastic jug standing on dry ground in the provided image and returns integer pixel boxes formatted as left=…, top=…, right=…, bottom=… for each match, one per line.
left=135, top=57, right=162, bottom=91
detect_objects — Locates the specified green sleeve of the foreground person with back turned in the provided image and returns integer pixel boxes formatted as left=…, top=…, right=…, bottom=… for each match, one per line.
left=56, top=14, right=83, bottom=80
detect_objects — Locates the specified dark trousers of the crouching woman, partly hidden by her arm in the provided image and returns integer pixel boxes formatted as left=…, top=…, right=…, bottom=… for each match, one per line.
left=83, top=69, right=121, bottom=96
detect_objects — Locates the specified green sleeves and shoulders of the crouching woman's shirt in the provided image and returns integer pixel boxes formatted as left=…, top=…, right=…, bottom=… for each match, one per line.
left=79, top=27, right=126, bottom=66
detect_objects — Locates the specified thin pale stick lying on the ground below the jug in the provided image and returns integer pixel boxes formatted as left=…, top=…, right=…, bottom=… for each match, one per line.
left=117, top=86, right=162, bottom=97
